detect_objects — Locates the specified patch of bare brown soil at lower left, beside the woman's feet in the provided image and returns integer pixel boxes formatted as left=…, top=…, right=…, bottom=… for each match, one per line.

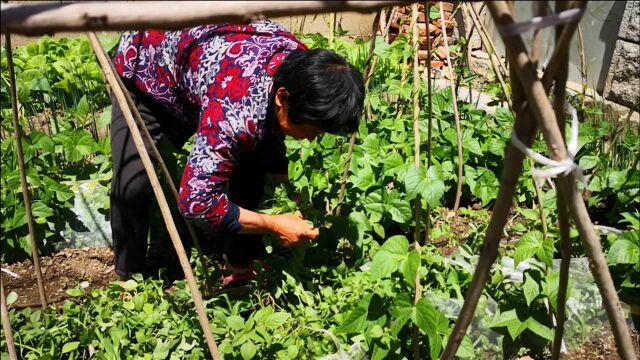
left=2, top=247, right=118, bottom=308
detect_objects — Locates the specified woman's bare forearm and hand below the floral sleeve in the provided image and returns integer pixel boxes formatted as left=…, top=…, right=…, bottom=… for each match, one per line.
left=238, top=208, right=320, bottom=247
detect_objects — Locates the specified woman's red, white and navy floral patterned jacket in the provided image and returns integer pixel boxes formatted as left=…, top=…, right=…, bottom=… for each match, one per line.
left=114, top=20, right=306, bottom=232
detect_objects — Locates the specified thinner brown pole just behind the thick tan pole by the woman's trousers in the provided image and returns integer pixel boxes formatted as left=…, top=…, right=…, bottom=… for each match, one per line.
left=89, top=37, right=213, bottom=289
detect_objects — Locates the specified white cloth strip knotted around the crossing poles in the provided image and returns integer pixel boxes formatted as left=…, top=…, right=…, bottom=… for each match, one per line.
left=511, top=102, right=586, bottom=185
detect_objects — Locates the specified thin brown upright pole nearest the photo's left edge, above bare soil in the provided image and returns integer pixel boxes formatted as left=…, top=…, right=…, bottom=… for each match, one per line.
left=4, top=34, right=47, bottom=309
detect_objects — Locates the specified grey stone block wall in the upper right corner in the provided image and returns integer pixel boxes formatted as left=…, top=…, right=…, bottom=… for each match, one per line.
left=603, top=1, right=640, bottom=111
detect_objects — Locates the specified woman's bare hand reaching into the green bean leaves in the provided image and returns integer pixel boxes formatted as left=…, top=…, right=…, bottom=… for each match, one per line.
left=269, top=214, right=320, bottom=247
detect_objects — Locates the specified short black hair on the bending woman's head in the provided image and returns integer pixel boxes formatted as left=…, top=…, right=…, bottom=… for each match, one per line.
left=273, top=49, right=365, bottom=134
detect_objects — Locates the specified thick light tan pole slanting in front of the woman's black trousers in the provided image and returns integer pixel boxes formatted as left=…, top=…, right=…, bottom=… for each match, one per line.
left=87, top=32, right=221, bottom=360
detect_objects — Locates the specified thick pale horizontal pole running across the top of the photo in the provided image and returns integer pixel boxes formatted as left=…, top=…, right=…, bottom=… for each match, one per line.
left=0, top=1, right=410, bottom=35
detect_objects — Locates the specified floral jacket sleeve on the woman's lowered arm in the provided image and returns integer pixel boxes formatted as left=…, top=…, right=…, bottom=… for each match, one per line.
left=179, top=99, right=247, bottom=232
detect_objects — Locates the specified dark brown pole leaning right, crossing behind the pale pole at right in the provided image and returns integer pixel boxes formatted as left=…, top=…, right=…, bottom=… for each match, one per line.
left=440, top=3, right=585, bottom=360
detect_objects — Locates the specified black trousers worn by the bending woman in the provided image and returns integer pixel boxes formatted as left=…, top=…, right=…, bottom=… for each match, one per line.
left=110, top=90, right=266, bottom=279
